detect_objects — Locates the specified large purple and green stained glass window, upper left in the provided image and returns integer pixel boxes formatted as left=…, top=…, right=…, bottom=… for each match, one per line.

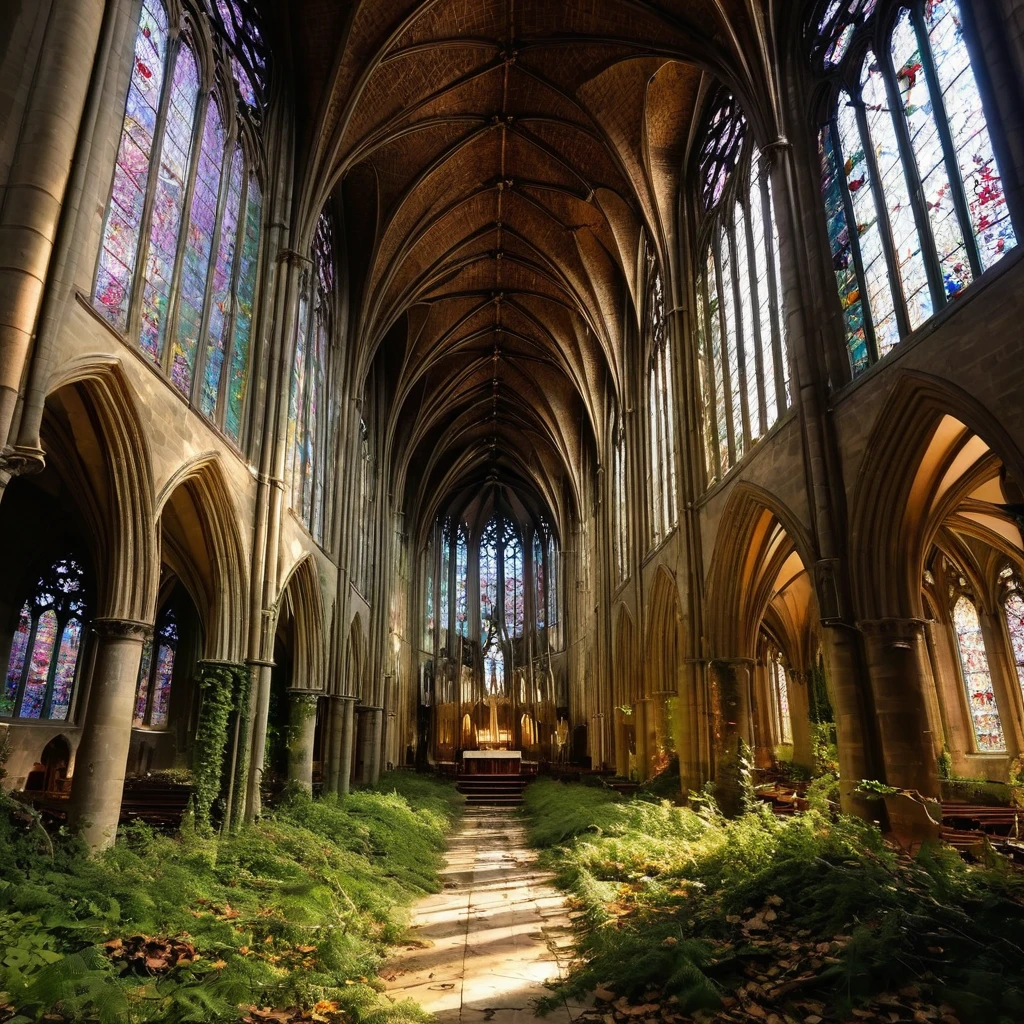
left=93, top=0, right=267, bottom=442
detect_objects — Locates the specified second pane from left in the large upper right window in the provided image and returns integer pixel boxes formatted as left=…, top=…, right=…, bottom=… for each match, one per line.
left=836, top=93, right=899, bottom=354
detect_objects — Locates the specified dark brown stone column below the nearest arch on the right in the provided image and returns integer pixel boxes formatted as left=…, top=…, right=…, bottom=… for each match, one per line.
left=860, top=618, right=939, bottom=797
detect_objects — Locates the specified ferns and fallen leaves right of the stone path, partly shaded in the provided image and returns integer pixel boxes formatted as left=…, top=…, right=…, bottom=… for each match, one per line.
left=525, top=780, right=1024, bottom=1024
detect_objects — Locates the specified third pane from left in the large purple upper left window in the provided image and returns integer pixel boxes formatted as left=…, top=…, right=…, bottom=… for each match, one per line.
left=171, top=98, right=224, bottom=398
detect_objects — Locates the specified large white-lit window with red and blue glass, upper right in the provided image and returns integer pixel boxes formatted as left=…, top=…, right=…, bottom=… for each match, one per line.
left=807, top=0, right=1017, bottom=375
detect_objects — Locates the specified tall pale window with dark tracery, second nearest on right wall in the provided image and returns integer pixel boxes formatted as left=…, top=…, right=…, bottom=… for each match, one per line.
left=696, top=90, right=791, bottom=484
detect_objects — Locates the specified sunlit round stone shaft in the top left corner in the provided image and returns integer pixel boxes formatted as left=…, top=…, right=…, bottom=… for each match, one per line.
left=0, top=0, right=105, bottom=455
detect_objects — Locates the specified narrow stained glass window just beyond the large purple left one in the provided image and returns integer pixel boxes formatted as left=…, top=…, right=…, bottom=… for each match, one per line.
left=286, top=211, right=333, bottom=544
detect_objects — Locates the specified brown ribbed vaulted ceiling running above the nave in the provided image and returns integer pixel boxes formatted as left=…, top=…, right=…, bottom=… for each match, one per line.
left=276, top=0, right=786, bottom=540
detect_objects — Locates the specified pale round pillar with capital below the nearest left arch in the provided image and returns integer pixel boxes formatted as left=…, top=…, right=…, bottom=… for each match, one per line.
left=70, top=618, right=153, bottom=850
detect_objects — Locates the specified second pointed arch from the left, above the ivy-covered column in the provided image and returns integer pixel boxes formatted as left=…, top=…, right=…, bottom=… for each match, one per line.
left=155, top=453, right=249, bottom=662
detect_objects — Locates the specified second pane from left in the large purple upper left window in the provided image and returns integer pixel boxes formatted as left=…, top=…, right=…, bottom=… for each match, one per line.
left=139, top=46, right=199, bottom=365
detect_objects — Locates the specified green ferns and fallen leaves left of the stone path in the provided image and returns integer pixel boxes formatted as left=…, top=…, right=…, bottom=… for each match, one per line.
left=0, top=773, right=461, bottom=1024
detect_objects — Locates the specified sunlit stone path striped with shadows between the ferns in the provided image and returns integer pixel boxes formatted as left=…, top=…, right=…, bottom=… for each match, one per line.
left=382, top=807, right=584, bottom=1024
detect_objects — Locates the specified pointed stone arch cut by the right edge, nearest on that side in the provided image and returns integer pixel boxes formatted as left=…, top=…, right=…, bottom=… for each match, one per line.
left=850, top=372, right=1024, bottom=620
